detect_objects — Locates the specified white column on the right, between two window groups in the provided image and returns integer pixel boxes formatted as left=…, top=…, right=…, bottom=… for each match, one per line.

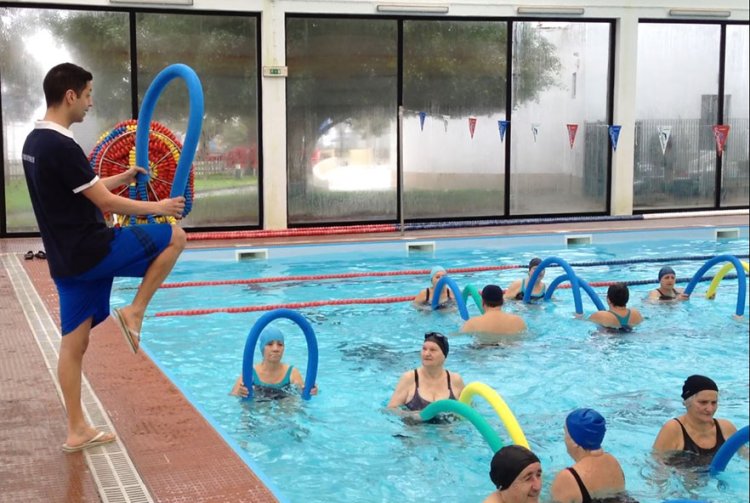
left=610, top=11, right=638, bottom=215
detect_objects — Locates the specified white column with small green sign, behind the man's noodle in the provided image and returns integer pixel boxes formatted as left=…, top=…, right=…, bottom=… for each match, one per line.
left=260, top=0, right=287, bottom=230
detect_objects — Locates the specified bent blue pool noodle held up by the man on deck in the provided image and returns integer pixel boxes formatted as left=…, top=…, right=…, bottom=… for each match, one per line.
left=135, top=63, right=203, bottom=203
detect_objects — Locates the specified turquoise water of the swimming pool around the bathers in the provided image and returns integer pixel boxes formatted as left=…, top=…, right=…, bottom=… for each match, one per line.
left=113, top=228, right=750, bottom=502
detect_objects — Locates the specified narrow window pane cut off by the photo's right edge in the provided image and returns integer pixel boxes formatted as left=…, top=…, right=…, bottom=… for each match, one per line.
left=721, top=25, right=750, bottom=206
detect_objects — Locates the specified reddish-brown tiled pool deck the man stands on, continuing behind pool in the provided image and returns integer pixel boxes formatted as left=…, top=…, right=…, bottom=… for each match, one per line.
left=0, top=214, right=748, bottom=503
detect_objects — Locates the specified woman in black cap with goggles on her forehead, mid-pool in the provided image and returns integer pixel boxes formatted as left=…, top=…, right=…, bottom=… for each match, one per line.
left=388, top=332, right=464, bottom=411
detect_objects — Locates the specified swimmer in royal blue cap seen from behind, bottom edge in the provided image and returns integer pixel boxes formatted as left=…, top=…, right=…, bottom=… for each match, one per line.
left=550, top=409, right=633, bottom=503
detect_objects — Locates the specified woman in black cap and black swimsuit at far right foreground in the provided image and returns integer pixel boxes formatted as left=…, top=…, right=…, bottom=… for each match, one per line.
left=654, top=375, right=737, bottom=464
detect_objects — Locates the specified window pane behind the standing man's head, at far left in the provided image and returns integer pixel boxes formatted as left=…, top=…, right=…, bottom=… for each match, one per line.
left=0, top=8, right=131, bottom=232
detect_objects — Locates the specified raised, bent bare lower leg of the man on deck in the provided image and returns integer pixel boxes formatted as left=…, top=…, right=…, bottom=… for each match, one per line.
left=120, top=225, right=187, bottom=346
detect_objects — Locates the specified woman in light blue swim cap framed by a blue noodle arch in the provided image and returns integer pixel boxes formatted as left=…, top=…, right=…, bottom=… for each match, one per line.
left=230, top=327, right=318, bottom=398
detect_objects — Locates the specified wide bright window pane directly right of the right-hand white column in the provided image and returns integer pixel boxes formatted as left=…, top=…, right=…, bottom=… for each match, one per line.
left=633, top=23, right=724, bottom=210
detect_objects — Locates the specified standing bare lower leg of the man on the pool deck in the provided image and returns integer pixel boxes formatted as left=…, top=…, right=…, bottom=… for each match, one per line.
left=57, top=318, right=114, bottom=447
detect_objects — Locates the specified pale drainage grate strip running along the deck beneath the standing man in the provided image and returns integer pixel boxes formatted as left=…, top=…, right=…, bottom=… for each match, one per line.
left=0, top=254, right=154, bottom=503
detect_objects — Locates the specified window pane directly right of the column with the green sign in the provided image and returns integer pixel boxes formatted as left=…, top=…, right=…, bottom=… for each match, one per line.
left=286, top=18, right=397, bottom=225
